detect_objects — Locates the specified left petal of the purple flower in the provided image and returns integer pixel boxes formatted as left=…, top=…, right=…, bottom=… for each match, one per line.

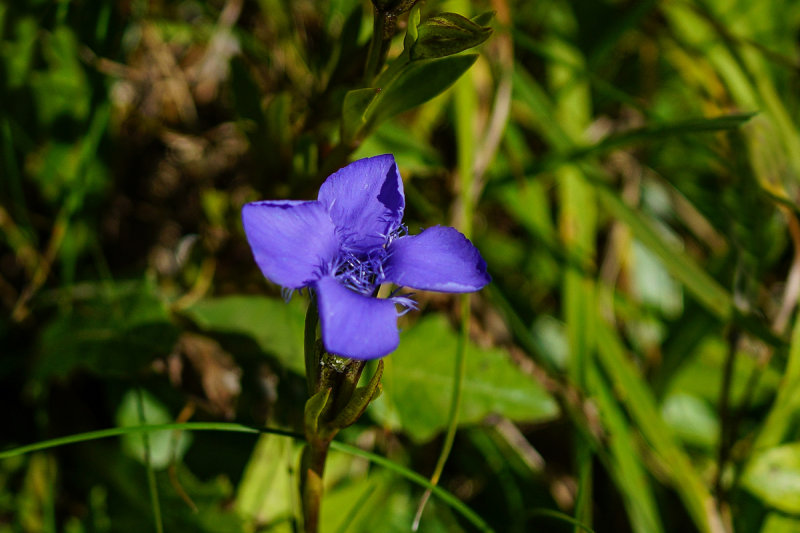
left=242, top=201, right=339, bottom=289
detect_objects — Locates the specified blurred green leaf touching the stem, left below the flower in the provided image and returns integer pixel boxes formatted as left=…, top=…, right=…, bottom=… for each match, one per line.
left=184, top=296, right=306, bottom=375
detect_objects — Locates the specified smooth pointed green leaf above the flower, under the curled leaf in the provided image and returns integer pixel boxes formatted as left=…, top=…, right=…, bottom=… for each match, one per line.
left=367, top=54, right=478, bottom=129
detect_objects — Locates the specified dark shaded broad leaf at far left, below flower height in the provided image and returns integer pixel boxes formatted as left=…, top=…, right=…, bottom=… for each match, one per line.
left=33, top=282, right=178, bottom=380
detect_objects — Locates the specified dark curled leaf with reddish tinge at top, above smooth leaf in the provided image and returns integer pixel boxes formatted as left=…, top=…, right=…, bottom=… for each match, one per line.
left=411, top=13, right=492, bottom=60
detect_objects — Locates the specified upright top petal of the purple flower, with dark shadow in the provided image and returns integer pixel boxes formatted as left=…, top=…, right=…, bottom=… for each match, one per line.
left=317, top=154, right=405, bottom=252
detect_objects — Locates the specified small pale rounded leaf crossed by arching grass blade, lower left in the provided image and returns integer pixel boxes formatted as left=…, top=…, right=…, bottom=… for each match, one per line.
left=116, top=389, right=192, bottom=470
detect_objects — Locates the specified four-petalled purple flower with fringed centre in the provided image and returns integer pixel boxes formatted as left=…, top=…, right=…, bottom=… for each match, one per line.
left=242, top=154, right=491, bottom=359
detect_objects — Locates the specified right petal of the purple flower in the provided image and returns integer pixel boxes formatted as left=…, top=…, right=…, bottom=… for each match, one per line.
left=384, top=226, right=492, bottom=292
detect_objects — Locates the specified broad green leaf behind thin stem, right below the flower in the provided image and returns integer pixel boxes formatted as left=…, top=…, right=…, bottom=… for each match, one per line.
left=369, top=314, right=558, bottom=442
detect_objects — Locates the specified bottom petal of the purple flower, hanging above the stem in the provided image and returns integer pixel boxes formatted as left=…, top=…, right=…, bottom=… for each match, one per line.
left=316, top=276, right=400, bottom=359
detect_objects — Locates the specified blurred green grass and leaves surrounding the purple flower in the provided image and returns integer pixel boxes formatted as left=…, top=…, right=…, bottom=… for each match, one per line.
left=0, top=0, right=800, bottom=533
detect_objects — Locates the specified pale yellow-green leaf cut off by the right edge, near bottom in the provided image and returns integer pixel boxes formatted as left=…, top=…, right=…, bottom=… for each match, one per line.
left=742, top=442, right=800, bottom=514
